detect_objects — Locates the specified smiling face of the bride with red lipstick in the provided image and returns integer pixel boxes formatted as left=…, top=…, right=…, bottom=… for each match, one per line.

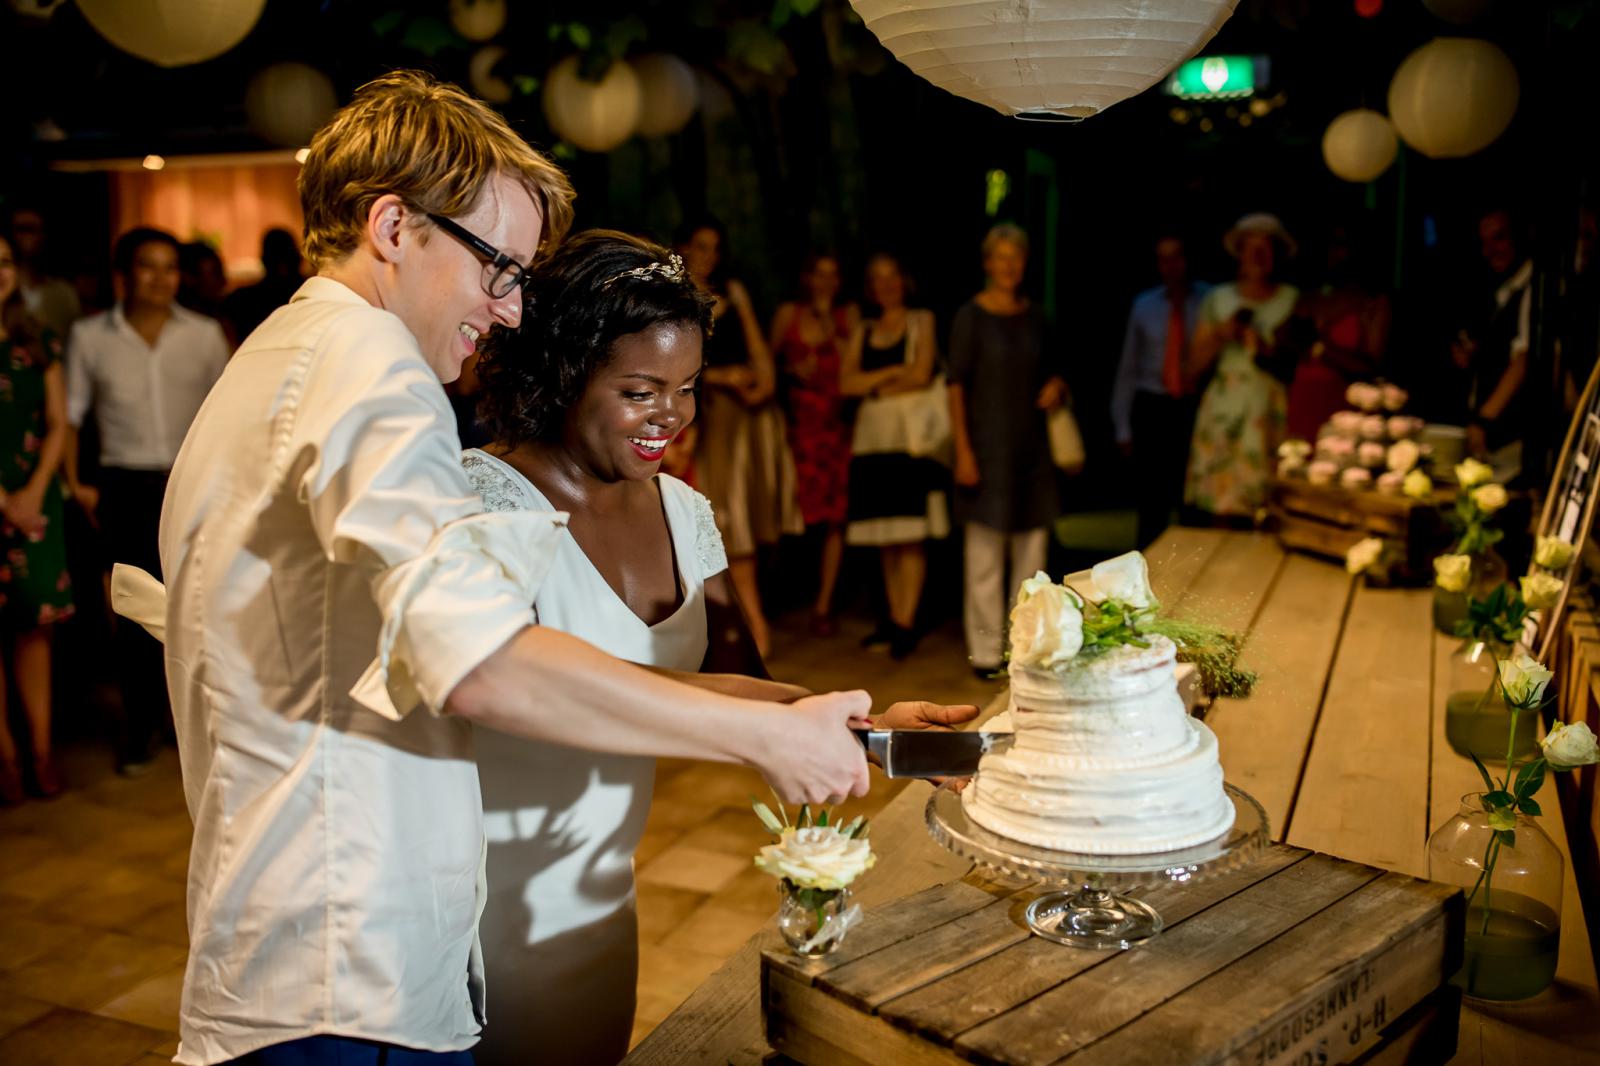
left=565, top=322, right=702, bottom=482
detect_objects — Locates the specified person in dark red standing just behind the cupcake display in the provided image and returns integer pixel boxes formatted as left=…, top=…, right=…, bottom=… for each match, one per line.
left=1278, top=226, right=1392, bottom=440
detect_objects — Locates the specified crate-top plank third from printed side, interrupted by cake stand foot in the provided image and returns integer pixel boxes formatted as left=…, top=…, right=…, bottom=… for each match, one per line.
left=878, top=845, right=1309, bottom=1040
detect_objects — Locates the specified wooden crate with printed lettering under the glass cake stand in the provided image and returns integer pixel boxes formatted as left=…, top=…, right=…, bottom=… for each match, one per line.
left=762, top=845, right=1464, bottom=1066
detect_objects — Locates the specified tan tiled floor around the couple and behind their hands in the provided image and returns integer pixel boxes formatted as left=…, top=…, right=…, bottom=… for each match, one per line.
left=0, top=615, right=997, bottom=1066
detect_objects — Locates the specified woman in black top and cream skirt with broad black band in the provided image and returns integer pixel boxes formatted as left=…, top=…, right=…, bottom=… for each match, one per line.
left=840, top=254, right=950, bottom=659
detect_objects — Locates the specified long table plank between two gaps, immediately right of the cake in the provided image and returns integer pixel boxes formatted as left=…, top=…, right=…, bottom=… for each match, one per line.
left=1205, top=555, right=1352, bottom=840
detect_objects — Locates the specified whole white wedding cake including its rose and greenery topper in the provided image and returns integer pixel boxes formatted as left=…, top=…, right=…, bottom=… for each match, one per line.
left=962, top=554, right=1234, bottom=855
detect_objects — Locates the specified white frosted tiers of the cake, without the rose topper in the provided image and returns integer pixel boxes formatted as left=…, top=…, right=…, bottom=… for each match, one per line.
left=962, top=635, right=1234, bottom=855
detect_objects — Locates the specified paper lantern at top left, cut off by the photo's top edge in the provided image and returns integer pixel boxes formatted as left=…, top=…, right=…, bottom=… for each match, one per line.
left=78, top=0, right=266, bottom=67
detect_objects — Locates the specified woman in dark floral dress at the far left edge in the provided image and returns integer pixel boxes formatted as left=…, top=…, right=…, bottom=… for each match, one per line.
left=0, top=234, right=72, bottom=804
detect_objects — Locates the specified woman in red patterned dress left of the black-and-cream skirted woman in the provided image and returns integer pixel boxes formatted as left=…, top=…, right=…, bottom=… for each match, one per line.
left=770, top=254, right=861, bottom=637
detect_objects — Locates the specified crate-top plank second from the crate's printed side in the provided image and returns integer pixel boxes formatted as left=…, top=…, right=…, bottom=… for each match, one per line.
left=957, top=855, right=1382, bottom=1063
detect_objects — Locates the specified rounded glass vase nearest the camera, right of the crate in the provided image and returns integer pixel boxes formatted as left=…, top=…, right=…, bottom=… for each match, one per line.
left=1427, top=792, right=1562, bottom=1000
